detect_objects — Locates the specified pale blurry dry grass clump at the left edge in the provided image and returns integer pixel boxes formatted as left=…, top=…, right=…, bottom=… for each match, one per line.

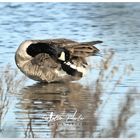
left=0, top=64, right=26, bottom=131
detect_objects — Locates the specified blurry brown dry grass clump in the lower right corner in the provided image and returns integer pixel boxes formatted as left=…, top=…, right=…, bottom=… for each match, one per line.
left=100, top=88, right=140, bottom=138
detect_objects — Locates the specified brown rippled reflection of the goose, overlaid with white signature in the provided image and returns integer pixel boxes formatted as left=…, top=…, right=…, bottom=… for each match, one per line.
left=16, top=83, right=99, bottom=138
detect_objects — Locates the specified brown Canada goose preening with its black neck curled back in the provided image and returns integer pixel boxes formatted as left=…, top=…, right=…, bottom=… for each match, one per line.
left=15, top=39, right=102, bottom=82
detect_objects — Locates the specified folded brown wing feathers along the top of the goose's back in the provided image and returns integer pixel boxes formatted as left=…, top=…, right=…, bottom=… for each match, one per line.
left=35, top=38, right=102, bottom=57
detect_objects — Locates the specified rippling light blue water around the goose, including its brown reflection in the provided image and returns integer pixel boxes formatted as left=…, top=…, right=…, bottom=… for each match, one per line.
left=0, top=3, right=140, bottom=138
